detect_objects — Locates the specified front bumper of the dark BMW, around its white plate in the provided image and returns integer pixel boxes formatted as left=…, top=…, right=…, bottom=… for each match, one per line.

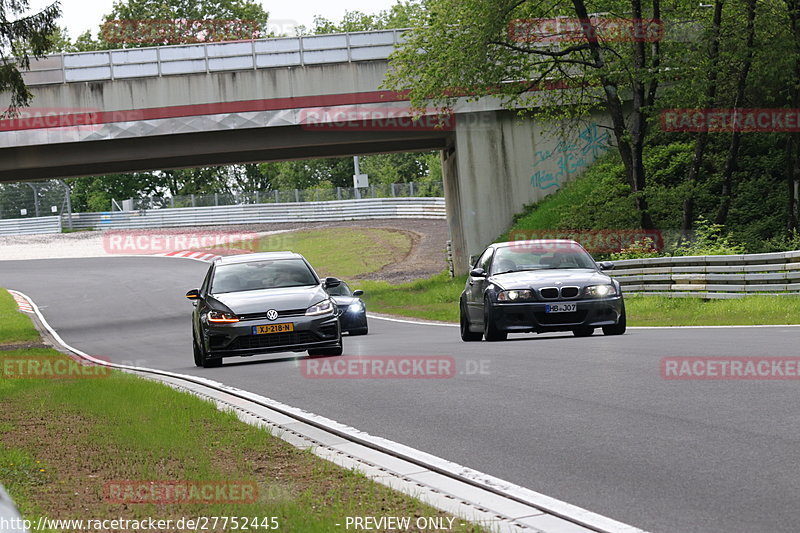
left=492, top=296, right=624, bottom=333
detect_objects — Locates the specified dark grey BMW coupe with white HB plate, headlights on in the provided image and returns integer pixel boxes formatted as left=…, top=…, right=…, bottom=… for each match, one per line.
left=460, top=239, right=626, bottom=341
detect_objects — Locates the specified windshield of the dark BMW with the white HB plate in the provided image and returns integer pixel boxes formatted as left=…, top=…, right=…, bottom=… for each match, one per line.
left=491, top=244, right=597, bottom=274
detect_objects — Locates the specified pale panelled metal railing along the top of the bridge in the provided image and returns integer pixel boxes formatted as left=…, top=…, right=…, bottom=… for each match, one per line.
left=24, top=30, right=406, bottom=85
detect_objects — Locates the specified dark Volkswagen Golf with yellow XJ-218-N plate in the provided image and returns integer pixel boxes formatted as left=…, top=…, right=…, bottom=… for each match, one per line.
left=186, top=252, right=342, bottom=367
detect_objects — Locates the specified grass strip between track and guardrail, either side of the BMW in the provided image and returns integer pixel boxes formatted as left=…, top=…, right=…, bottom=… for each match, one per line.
left=358, top=273, right=800, bottom=326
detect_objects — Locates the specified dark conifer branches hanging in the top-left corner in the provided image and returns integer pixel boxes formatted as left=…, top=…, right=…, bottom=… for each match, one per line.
left=0, top=0, right=61, bottom=116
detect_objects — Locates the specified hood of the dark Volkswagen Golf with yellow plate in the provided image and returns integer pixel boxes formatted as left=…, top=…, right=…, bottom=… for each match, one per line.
left=213, top=285, right=329, bottom=314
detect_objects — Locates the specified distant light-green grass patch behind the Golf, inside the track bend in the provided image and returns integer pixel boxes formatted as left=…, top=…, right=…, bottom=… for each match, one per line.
left=225, top=227, right=412, bottom=278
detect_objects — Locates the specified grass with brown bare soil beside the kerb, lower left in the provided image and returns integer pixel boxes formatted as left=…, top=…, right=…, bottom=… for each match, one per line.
left=0, top=290, right=480, bottom=532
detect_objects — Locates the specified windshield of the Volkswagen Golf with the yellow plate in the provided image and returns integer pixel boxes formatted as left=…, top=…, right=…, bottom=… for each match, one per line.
left=211, top=259, right=319, bottom=294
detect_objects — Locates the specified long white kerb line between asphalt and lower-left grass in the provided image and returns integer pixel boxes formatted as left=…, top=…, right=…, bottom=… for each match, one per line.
left=8, top=288, right=646, bottom=533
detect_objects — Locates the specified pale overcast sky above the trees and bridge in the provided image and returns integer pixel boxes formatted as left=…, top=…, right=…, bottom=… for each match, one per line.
left=31, top=0, right=395, bottom=38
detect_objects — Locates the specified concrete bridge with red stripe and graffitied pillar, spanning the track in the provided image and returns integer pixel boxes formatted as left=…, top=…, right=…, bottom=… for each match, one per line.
left=0, top=30, right=608, bottom=272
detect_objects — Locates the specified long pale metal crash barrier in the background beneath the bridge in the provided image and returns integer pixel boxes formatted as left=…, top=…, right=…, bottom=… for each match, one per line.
left=65, top=198, right=446, bottom=229
